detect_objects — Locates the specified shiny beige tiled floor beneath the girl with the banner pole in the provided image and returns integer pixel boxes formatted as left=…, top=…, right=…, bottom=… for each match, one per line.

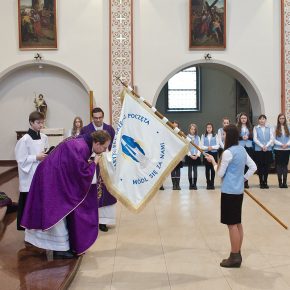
left=70, top=168, right=290, bottom=290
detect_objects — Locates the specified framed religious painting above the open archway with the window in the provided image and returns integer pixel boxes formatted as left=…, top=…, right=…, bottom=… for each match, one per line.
left=189, top=0, right=226, bottom=50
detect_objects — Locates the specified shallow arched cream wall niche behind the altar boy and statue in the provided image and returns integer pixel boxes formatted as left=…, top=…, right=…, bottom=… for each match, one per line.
left=0, top=61, right=91, bottom=160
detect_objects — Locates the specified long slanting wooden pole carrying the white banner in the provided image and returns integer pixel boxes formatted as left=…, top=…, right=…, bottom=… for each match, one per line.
left=116, top=77, right=288, bottom=230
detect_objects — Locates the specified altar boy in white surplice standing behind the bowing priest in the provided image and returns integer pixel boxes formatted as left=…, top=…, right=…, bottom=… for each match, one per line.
left=15, top=111, right=49, bottom=230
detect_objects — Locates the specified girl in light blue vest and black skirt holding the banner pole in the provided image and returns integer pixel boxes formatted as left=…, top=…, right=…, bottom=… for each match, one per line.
left=206, top=125, right=257, bottom=268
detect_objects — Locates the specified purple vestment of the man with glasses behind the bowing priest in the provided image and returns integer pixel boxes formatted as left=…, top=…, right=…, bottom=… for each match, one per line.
left=81, top=123, right=117, bottom=207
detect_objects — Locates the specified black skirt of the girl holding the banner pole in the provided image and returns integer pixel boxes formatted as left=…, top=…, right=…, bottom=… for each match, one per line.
left=221, top=192, right=244, bottom=225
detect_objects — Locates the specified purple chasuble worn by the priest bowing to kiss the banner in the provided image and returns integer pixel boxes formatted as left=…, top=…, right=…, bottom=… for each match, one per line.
left=21, top=138, right=99, bottom=254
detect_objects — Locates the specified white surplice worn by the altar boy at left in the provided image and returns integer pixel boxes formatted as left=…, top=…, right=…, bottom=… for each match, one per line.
left=15, top=133, right=49, bottom=192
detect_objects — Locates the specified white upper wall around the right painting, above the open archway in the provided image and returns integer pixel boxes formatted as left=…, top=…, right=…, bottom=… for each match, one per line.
left=134, top=0, right=281, bottom=123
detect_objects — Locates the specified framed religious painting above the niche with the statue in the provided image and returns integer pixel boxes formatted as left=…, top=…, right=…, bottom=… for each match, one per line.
left=18, top=0, right=57, bottom=50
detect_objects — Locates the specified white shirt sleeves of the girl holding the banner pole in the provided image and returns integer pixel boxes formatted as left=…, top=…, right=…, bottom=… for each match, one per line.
left=214, top=149, right=257, bottom=180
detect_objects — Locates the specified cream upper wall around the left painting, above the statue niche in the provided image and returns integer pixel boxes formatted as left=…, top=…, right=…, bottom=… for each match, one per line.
left=0, top=0, right=109, bottom=116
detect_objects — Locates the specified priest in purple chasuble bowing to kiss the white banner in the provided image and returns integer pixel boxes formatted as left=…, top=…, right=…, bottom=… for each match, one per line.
left=21, top=130, right=111, bottom=259
